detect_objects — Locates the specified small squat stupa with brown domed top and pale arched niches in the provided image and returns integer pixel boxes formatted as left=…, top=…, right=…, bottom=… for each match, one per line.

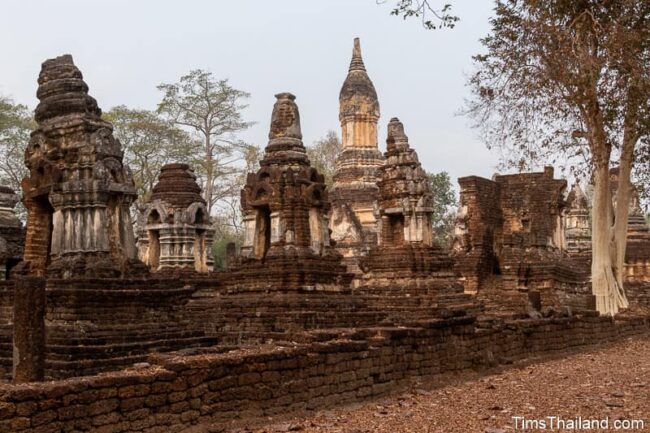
left=138, top=164, right=214, bottom=272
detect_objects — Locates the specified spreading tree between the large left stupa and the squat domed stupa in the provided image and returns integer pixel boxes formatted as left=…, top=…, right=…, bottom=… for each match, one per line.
left=103, top=105, right=195, bottom=204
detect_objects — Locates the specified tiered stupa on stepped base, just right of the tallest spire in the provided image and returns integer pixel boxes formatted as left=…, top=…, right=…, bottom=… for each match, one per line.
left=361, top=118, right=462, bottom=292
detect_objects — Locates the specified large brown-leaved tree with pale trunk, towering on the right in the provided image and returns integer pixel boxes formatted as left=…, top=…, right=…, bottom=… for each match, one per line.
left=468, top=0, right=650, bottom=315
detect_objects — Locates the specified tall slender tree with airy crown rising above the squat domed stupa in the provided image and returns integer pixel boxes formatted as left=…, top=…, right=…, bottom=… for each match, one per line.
left=158, top=69, right=251, bottom=216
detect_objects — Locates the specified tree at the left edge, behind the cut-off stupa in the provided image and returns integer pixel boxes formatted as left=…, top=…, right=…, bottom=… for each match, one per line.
left=0, top=95, right=35, bottom=221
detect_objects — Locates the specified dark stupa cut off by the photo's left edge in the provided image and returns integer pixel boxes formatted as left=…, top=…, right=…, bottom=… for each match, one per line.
left=0, top=186, right=25, bottom=280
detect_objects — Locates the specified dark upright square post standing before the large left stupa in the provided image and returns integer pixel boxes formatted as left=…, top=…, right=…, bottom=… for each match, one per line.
left=13, top=277, right=45, bottom=383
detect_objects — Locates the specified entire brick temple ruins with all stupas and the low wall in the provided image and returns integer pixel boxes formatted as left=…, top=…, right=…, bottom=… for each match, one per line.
left=0, top=47, right=650, bottom=433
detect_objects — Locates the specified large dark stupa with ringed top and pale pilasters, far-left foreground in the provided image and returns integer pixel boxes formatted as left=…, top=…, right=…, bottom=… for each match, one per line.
left=22, top=55, right=142, bottom=278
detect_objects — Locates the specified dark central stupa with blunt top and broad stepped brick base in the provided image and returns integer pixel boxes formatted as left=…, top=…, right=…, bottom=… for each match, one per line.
left=227, top=93, right=350, bottom=290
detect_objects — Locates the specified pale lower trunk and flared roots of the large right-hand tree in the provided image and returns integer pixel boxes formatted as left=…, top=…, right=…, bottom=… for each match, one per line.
left=591, top=162, right=627, bottom=316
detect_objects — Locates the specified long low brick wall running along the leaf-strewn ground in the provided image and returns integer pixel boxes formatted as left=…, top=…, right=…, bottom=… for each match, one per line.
left=0, top=314, right=649, bottom=433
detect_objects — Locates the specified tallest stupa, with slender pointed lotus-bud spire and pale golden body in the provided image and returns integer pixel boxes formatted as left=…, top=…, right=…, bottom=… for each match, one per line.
left=330, top=38, right=383, bottom=273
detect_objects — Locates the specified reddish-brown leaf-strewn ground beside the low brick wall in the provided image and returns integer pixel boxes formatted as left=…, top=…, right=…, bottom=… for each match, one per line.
left=216, top=338, right=650, bottom=433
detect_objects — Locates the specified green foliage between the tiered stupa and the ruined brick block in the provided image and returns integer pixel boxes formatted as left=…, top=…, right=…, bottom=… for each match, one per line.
left=427, top=171, right=457, bottom=247
